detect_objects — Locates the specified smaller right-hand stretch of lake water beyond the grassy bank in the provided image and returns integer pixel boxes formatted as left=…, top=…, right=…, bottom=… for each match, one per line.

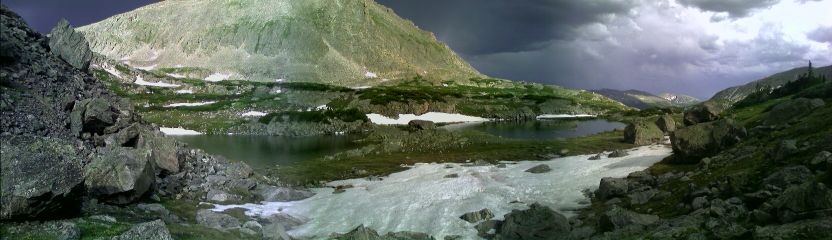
left=445, top=119, right=627, bottom=140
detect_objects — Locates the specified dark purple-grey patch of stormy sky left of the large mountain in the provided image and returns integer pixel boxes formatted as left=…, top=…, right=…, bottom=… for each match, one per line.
left=2, top=0, right=154, bottom=33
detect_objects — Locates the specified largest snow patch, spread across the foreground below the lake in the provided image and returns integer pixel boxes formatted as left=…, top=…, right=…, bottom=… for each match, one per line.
left=213, top=145, right=672, bottom=239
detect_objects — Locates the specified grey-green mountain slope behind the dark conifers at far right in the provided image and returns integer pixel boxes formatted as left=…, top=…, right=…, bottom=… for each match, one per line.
left=709, top=65, right=832, bottom=105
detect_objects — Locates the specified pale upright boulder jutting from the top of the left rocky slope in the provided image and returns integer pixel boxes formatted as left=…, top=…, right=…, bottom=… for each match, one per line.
left=49, top=19, right=92, bottom=71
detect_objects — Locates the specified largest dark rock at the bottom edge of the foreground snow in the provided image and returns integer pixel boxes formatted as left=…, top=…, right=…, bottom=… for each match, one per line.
left=497, top=203, right=571, bottom=239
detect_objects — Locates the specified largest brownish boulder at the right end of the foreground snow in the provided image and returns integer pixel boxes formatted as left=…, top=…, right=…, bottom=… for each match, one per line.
left=670, top=119, right=747, bottom=163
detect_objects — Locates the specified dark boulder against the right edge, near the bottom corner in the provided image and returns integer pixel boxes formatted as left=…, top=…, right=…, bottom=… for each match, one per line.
left=772, top=182, right=832, bottom=222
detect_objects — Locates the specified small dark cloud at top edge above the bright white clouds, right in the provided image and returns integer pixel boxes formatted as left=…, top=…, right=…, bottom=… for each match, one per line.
left=679, top=0, right=780, bottom=18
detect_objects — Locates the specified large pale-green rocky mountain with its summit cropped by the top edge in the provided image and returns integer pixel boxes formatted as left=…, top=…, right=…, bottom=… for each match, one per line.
left=78, top=0, right=482, bottom=86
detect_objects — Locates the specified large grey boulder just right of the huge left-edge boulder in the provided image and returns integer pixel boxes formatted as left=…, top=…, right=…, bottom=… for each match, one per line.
left=84, top=147, right=156, bottom=204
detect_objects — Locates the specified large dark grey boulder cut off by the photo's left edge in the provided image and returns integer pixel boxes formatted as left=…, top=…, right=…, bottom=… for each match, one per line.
left=0, top=137, right=83, bottom=220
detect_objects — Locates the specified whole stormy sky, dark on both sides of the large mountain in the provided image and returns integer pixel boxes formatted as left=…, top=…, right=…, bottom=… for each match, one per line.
left=3, top=0, right=832, bottom=98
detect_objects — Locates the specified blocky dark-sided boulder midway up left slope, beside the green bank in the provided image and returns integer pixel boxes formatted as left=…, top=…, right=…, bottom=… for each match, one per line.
left=70, top=98, right=118, bottom=136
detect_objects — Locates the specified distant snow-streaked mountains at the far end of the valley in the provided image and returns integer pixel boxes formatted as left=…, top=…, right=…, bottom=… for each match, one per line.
left=592, top=88, right=699, bottom=109
